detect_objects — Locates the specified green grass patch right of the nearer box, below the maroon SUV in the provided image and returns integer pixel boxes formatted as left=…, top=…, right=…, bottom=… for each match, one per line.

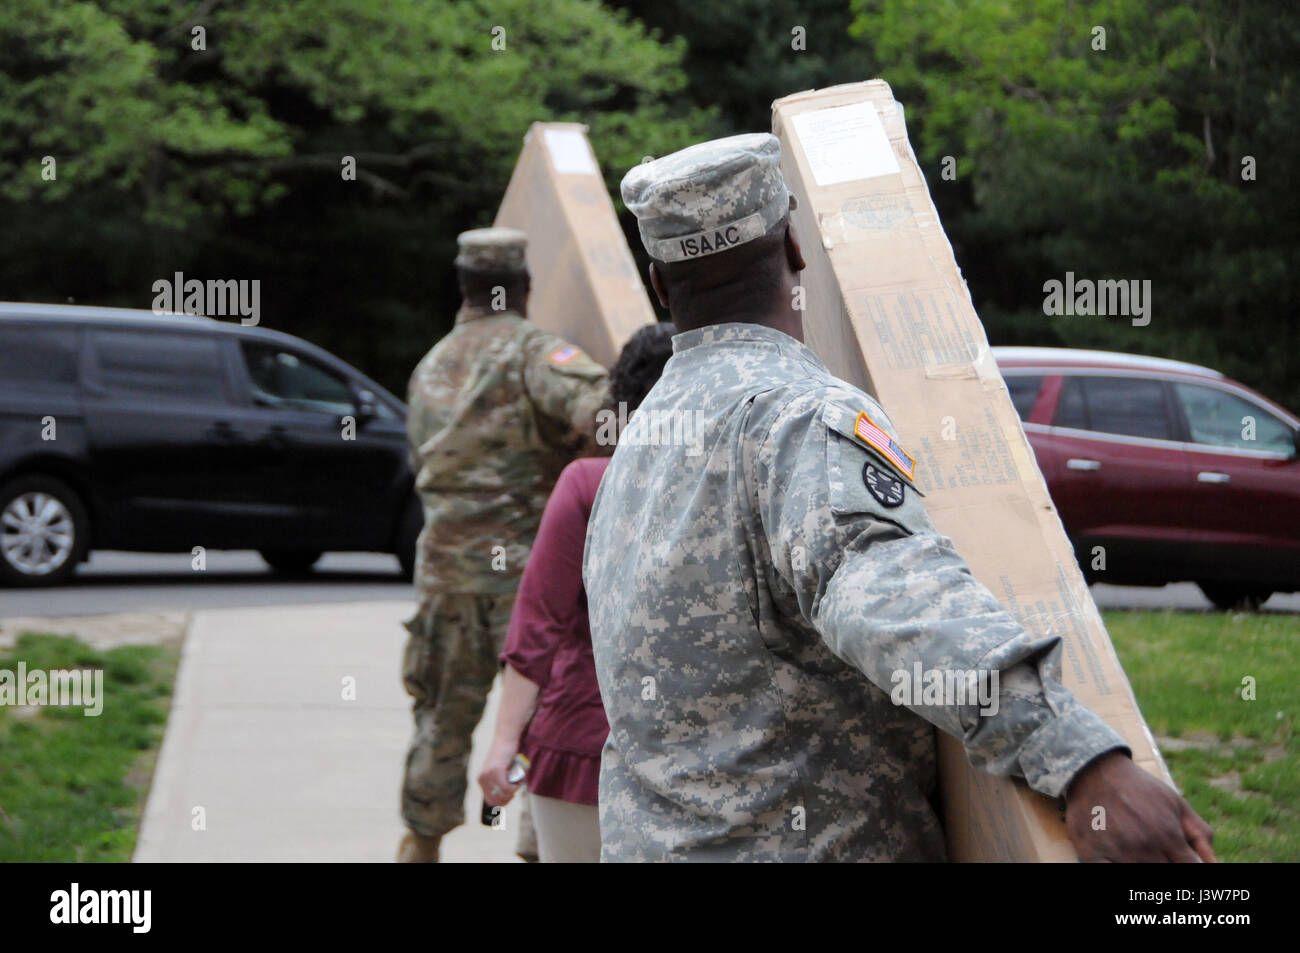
left=1104, top=611, right=1300, bottom=861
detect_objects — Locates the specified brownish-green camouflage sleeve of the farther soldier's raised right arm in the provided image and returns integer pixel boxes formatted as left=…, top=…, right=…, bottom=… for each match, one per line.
left=524, top=330, right=610, bottom=452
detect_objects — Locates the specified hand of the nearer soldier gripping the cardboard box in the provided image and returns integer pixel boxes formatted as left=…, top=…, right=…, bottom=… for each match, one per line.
left=1065, top=751, right=1214, bottom=863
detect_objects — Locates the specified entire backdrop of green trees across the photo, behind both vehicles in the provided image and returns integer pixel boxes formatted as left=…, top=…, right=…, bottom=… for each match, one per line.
left=0, top=0, right=1300, bottom=410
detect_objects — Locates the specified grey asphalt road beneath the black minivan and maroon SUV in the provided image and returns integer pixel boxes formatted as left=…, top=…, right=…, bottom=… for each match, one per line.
left=0, top=551, right=1300, bottom=618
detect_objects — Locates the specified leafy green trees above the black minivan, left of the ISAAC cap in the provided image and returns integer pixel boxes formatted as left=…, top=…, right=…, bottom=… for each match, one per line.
left=0, top=0, right=709, bottom=389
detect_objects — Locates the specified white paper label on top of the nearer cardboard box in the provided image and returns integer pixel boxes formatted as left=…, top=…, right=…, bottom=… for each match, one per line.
left=792, top=103, right=898, bottom=186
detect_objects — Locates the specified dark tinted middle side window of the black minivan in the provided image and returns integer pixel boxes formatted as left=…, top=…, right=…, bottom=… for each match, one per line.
left=94, top=329, right=226, bottom=402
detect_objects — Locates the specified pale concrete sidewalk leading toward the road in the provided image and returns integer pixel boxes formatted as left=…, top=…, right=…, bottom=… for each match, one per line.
left=134, top=602, right=519, bottom=862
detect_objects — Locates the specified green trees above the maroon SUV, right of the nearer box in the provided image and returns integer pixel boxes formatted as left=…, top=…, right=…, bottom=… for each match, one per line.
left=853, top=0, right=1300, bottom=410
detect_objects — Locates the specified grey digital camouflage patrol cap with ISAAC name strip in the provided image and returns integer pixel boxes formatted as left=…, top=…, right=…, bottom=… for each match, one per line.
left=621, top=133, right=794, bottom=261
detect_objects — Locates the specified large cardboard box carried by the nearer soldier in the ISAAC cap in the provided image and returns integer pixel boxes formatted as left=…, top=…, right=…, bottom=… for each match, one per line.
left=772, top=79, right=1171, bottom=861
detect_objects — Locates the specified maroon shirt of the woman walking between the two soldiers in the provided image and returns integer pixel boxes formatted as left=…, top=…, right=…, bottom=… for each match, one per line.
left=501, top=456, right=610, bottom=805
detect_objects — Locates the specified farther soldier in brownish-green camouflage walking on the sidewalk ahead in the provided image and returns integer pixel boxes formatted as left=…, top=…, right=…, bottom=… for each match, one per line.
left=399, top=229, right=608, bottom=861
